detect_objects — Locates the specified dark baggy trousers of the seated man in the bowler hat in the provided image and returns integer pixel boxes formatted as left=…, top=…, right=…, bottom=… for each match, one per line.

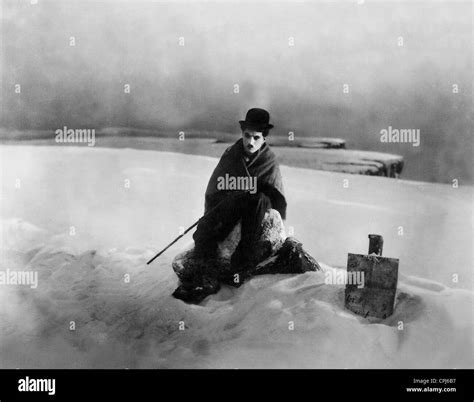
left=193, top=193, right=272, bottom=268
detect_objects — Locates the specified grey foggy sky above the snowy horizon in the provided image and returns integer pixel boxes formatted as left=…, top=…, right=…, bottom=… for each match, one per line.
left=0, top=0, right=473, bottom=185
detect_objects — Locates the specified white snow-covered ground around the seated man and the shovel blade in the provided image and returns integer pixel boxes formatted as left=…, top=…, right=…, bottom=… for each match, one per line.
left=0, top=146, right=474, bottom=368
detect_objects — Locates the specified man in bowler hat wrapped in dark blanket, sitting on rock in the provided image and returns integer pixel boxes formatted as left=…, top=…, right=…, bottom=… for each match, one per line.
left=173, top=108, right=317, bottom=302
